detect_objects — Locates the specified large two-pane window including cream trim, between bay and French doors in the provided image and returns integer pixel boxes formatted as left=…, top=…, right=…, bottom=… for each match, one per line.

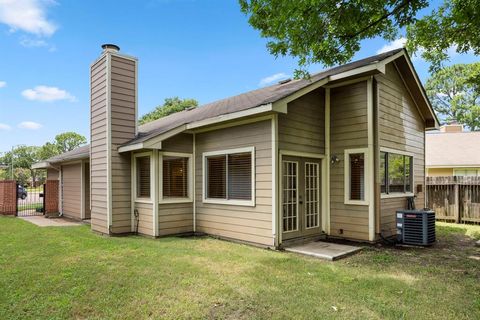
left=204, top=148, right=254, bottom=205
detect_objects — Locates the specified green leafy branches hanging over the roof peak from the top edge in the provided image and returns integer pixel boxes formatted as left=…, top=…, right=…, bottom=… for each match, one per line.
left=239, top=0, right=480, bottom=77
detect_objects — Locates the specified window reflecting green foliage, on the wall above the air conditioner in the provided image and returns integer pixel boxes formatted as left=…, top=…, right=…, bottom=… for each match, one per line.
left=379, top=152, right=413, bottom=194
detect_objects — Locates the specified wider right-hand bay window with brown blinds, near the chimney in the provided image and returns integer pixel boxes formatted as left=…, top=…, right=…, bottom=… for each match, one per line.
left=162, top=156, right=189, bottom=198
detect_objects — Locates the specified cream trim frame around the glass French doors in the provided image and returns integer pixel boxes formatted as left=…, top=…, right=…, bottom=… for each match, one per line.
left=277, top=149, right=330, bottom=245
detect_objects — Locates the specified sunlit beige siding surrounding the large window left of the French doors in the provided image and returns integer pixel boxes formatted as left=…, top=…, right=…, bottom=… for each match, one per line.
left=195, top=120, right=274, bottom=246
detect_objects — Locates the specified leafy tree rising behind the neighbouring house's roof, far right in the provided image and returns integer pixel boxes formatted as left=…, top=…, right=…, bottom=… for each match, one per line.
left=425, top=62, right=480, bottom=131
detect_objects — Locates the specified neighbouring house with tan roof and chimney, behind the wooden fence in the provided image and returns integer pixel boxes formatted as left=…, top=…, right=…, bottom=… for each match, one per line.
left=426, top=124, right=480, bottom=177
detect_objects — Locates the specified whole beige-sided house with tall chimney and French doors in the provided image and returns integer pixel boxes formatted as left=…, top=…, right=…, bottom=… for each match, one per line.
left=32, top=45, right=438, bottom=248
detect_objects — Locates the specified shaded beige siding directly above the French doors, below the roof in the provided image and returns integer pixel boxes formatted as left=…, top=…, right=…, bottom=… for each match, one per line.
left=278, top=89, right=325, bottom=154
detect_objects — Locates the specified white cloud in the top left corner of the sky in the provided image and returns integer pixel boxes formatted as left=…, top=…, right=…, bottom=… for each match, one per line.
left=0, top=0, right=57, bottom=36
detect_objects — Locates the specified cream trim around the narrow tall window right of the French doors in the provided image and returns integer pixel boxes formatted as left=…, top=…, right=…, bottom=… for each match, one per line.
left=343, top=148, right=370, bottom=206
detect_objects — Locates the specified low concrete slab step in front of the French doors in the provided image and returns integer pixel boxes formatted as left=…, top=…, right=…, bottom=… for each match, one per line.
left=285, top=241, right=362, bottom=261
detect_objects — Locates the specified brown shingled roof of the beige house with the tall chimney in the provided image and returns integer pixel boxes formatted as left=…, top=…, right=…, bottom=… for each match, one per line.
left=33, top=49, right=438, bottom=169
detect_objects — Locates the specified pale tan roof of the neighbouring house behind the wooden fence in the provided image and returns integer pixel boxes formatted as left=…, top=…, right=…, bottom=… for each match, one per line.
left=425, top=132, right=480, bottom=168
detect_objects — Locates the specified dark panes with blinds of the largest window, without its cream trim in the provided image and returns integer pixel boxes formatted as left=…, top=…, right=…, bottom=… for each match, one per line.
left=206, top=152, right=252, bottom=200
